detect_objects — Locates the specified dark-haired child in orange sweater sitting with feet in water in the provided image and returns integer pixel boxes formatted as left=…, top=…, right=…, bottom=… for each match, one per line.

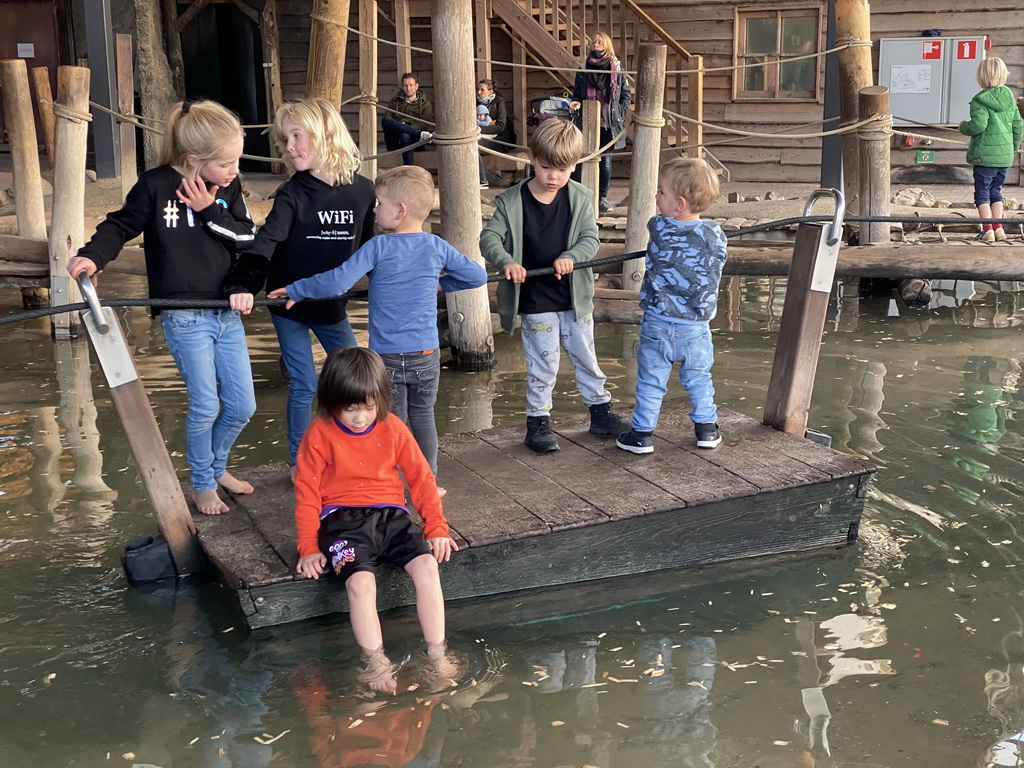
left=295, top=347, right=459, bottom=692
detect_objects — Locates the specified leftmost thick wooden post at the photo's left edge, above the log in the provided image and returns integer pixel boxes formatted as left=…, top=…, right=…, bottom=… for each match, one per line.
left=0, top=58, right=47, bottom=240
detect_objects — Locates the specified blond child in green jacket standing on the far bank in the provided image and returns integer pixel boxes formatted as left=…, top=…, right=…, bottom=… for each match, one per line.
left=959, top=56, right=1022, bottom=243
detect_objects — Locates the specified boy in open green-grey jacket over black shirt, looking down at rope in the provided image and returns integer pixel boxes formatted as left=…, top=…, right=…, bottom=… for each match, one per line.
left=480, top=119, right=626, bottom=454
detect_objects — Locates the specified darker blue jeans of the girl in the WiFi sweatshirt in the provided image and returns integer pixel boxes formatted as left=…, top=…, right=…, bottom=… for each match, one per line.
left=270, top=314, right=355, bottom=466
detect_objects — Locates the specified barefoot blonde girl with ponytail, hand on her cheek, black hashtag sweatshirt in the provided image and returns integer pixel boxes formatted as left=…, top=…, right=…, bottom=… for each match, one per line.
left=68, top=101, right=256, bottom=515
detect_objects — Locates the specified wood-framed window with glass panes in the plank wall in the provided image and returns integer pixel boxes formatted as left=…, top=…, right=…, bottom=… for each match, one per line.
left=733, top=6, right=821, bottom=99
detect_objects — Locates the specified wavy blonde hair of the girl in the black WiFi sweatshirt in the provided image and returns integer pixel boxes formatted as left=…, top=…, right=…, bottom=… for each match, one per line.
left=270, top=97, right=359, bottom=184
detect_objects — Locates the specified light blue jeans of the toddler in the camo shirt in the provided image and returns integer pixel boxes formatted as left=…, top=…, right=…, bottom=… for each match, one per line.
left=633, top=313, right=718, bottom=432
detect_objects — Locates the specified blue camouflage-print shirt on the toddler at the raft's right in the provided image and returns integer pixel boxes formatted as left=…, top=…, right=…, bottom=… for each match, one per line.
left=640, top=216, right=728, bottom=323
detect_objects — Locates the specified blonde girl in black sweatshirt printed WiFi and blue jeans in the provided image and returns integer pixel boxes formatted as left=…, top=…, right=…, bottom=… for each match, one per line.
left=226, top=98, right=377, bottom=476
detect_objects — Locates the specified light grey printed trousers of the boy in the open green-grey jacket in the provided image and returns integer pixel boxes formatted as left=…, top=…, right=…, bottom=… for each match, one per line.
left=522, top=309, right=611, bottom=416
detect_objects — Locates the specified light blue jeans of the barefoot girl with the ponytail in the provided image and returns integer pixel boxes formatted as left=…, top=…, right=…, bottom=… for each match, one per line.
left=160, top=309, right=256, bottom=494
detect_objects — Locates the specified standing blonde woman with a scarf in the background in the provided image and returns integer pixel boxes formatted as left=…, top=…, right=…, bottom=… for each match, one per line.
left=570, top=32, right=633, bottom=213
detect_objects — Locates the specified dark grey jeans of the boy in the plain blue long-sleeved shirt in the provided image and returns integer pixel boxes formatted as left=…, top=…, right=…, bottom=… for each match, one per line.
left=381, top=349, right=441, bottom=475
